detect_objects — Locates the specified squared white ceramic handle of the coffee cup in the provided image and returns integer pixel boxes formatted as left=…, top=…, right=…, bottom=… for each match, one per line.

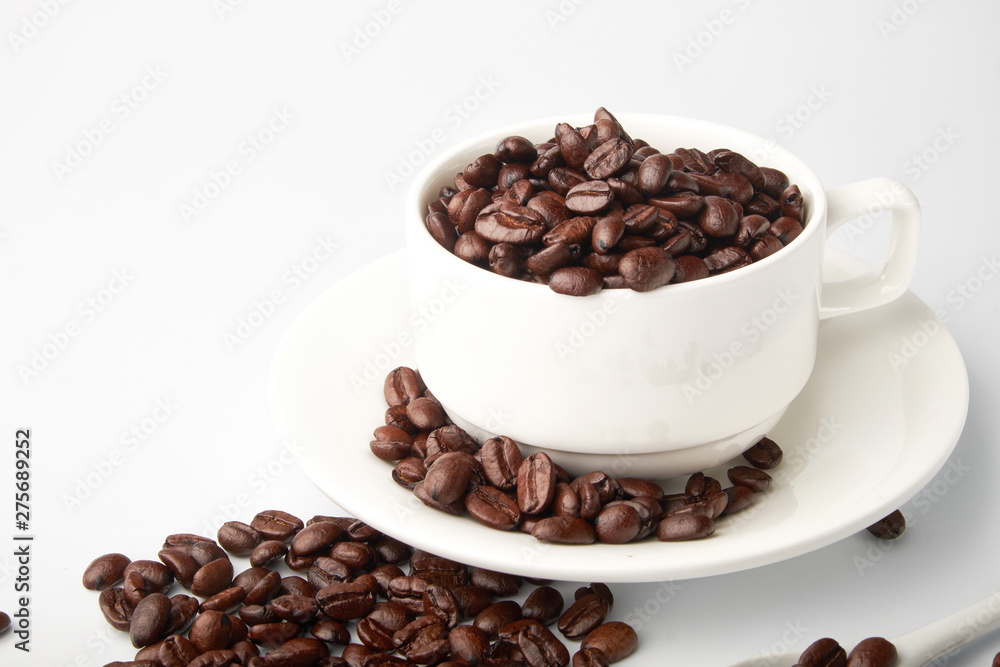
left=819, top=178, right=920, bottom=319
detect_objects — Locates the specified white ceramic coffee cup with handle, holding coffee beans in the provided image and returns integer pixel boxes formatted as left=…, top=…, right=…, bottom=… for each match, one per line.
left=405, top=114, right=920, bottom=474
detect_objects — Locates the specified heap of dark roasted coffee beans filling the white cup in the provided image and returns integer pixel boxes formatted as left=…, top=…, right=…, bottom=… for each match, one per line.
left=425, top=107, right=805, bottom=296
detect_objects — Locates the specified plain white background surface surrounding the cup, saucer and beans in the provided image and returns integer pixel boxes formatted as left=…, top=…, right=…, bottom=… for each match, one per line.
left=0, top=0, right=1000, bottom=666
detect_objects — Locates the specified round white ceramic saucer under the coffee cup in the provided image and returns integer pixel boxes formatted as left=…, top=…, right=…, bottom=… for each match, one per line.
left=270, top=249, right=969, bottom=582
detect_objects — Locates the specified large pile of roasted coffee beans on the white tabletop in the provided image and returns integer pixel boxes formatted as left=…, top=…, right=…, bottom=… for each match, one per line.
left=83, top=510, right=638, bottom=667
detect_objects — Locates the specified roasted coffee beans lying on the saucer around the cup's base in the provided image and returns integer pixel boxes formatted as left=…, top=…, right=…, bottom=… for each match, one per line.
left=369, top=367, right=782, bottom=544
